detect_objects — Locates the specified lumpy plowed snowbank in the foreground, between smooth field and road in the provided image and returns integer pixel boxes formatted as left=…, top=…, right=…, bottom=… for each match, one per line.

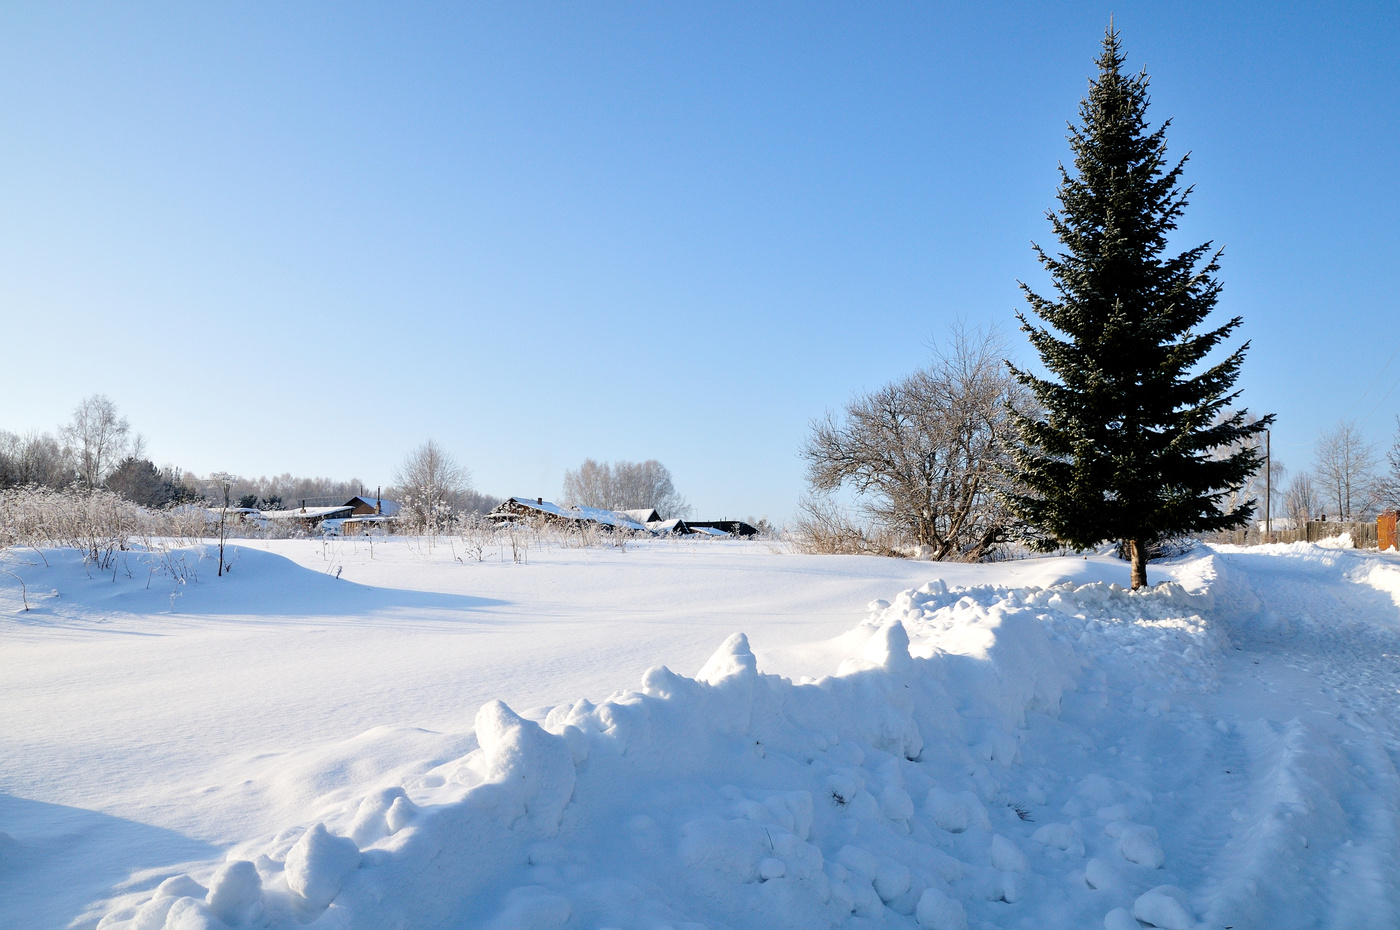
left=99, top=581, right=1237, bottom=930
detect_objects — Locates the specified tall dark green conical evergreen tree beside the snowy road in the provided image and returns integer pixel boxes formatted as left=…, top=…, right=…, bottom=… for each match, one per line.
left=1009, top=27, right=1273, bottom=588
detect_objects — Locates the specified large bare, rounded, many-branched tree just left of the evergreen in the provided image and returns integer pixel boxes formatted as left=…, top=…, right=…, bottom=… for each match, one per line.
left=802, top=328, right=1026, bottom=562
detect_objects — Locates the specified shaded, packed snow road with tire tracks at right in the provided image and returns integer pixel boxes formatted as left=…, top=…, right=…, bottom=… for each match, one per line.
left=1212, top=546, right=1400, bottom=930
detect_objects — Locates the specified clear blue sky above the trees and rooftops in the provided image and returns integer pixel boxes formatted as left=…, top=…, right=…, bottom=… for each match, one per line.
left=0, top=1, right=1400, bottom=518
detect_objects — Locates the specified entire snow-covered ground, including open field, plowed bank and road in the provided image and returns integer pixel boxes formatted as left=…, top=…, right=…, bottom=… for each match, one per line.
left=0, top=539, right=1400, bottom=930
